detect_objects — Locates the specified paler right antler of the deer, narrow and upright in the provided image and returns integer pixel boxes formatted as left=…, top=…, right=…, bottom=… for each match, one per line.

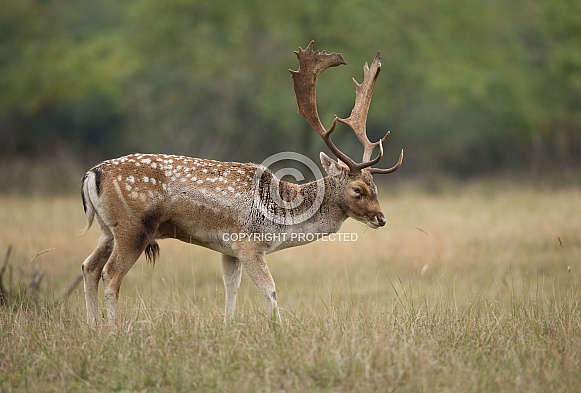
left=337, top=52, right=389, bottom=169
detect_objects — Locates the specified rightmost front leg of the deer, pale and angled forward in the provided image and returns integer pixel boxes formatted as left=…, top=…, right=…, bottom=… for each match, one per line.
left=239, top=252, right=281, bottom=323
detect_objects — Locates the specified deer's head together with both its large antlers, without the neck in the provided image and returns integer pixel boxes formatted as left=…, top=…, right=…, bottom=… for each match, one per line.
left=290, top=41, right=403, bottom=228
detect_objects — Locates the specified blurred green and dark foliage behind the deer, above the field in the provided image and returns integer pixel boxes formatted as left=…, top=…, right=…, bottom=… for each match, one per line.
left=0, top=0, right=581, bottom=189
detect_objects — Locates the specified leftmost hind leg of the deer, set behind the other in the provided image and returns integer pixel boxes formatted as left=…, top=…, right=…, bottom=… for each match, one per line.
left=82, top=228, right=115, bottom=327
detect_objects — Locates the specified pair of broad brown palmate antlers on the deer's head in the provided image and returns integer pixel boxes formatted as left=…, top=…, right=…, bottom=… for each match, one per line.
left=290, top=41, right=403, bottom=173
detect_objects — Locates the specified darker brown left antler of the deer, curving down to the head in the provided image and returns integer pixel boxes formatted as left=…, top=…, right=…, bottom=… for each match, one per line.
left=289, top=41, right=357, bottom=171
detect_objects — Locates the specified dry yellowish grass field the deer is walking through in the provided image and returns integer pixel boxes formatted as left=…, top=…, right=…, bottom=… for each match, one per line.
left=0, top=184, right=581, bottom=393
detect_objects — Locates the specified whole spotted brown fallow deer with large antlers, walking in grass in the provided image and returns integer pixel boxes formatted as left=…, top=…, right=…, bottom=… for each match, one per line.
left=81, top=41, right=403, bottom=326
